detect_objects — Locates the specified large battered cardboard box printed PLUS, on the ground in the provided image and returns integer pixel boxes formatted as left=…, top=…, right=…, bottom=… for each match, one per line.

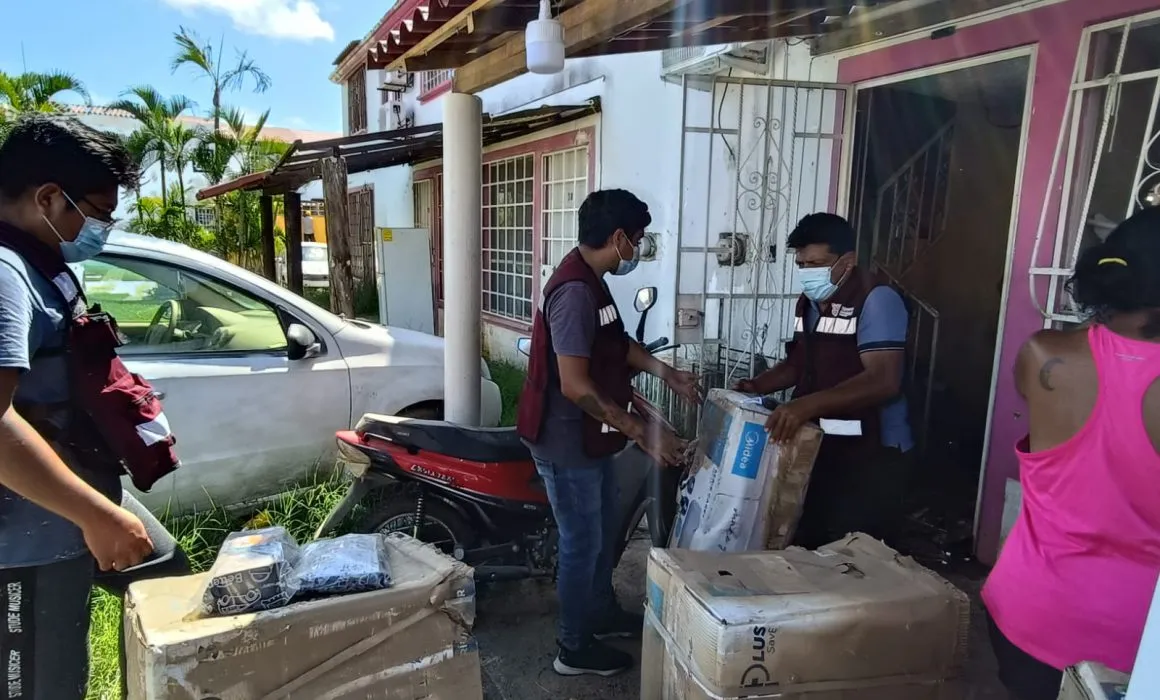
left=640, top=534, right=971, bottom=700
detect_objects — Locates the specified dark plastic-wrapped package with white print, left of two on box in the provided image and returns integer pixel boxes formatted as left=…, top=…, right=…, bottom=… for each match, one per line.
left=196, top=527, right=300, bottom=616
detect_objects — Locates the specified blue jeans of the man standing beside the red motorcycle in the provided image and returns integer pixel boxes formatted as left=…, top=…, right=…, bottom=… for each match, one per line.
left=536, top=457, right=621, bottom=650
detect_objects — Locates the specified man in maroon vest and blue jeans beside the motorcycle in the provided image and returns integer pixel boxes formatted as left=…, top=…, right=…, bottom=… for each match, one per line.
left=519, top=189, right=699, bottom=676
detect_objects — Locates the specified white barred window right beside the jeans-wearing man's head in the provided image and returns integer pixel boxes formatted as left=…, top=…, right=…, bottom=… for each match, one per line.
left=539, top=146, right=588, bottom=268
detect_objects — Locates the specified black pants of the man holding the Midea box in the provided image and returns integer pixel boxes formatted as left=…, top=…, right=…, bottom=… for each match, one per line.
left=793, top=436, right=913, bottom=549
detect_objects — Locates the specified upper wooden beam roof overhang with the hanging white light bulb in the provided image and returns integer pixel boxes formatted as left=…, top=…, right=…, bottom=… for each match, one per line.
left=335, top=0, right=914, bottom=93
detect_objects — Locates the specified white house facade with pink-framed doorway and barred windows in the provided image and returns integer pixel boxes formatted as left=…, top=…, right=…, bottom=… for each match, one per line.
left=335, top=0, right=1160, bottom=562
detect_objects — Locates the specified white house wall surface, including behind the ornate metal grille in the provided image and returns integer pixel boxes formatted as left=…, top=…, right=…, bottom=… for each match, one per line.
left=343, top=44, right=840, bottom=366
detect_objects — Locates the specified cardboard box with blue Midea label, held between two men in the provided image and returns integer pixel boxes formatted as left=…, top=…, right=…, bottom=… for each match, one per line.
left=669, top=389, right=821, bottom=551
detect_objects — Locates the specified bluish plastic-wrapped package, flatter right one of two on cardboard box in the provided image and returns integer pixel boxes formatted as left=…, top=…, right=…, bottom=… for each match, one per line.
left=291, top=534, right=391, bottom=596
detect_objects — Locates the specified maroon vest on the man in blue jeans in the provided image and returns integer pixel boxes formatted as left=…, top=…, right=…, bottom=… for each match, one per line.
left=516, top=248, right=632, bottom=457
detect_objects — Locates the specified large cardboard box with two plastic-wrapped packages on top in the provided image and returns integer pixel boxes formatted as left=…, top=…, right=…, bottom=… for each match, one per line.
left=125, top=534, right=483, bottom=700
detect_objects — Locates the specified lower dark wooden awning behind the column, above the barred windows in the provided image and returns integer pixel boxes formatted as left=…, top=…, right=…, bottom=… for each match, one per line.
left=197, top=98, right=600, bottom=200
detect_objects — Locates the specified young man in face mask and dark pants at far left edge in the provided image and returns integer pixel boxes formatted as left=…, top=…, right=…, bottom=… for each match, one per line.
left=0, top=115, right=188, bottom=700
